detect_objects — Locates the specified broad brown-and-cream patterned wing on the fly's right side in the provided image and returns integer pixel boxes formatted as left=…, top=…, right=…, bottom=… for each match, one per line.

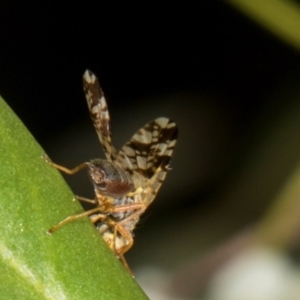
left=117, top=118, right=178, bottom=204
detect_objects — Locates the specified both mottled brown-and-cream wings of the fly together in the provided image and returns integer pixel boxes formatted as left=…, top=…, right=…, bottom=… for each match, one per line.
left=83, top=70, right=178, bottom=204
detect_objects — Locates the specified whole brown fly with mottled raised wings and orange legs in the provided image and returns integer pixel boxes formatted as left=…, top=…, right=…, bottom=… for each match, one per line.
left=44, top=70, right=177, bottom=274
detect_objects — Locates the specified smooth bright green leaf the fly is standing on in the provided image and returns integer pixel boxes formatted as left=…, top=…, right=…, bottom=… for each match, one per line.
left=0, top=98, right=147, bottom=300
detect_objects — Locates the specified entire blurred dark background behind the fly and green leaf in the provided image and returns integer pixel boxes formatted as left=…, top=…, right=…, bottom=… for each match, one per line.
left=0, top=0, right=300, bottom=300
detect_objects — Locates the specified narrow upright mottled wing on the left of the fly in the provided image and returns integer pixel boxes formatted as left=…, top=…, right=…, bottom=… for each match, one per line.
left=83, top=70, right=117, bottom=161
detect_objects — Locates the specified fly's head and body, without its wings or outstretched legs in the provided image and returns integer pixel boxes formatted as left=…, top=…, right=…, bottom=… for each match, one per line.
left=88, top=159, right=141, bottom=253
